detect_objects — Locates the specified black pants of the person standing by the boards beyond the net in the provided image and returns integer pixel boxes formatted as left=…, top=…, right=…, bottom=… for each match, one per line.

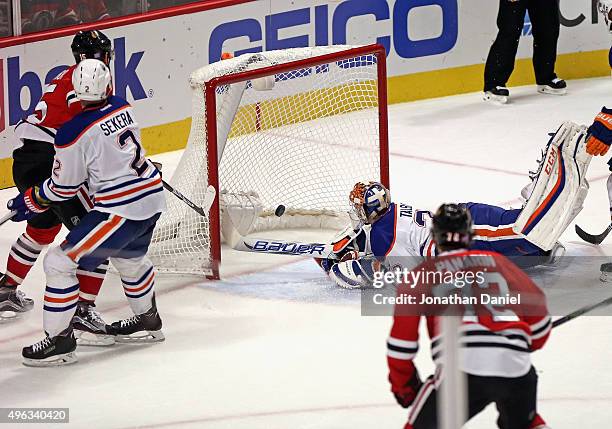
left=484, top=0, right=560, bottom=91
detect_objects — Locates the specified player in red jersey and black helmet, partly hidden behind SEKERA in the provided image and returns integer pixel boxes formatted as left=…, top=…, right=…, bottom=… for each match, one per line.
left=0, top=30, right=114, bottom=345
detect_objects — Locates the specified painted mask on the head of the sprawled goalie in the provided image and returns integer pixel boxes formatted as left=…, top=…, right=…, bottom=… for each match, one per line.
left=349, top=182, right=391, bottom=224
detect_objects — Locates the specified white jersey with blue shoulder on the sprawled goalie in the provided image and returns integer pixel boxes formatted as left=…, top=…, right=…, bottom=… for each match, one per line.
left=370, top=203, right=435, bottom=268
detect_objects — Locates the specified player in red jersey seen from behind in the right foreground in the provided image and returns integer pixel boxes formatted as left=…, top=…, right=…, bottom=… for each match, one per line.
left=387, top=204, right=552, bottom=429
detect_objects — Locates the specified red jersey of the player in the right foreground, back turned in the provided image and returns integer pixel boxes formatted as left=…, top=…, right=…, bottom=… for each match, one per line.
left=387, top=250, right=552, bottom=393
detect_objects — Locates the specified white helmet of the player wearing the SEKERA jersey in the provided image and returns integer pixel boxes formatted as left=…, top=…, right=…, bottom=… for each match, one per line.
left=72, top=58, right=111, bottom=101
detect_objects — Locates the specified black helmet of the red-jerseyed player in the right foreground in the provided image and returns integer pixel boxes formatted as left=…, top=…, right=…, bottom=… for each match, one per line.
left=431, top=204, right=473, bottom=250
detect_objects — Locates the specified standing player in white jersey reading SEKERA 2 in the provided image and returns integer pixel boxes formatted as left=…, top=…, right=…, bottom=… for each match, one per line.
left=8, top=59, right=166, bottom=366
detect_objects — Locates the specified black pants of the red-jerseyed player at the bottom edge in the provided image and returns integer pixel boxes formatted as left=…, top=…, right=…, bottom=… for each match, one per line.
left=412, top=367, right=538, bottom=429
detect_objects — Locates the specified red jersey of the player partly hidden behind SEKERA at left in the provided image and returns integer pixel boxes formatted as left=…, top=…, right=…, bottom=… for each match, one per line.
left=15, top=65, right=83, bottom=144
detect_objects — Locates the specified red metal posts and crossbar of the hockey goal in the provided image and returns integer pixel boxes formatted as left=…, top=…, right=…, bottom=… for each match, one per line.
left=204, top=44, right=390, bottom=280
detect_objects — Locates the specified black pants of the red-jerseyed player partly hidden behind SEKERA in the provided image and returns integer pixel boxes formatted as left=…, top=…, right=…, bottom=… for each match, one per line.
left=13, top=140, right=87, bottom=229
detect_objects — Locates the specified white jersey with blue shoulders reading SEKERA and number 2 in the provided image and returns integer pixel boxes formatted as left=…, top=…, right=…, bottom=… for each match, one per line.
left=41, top=96, right=166, bottom=220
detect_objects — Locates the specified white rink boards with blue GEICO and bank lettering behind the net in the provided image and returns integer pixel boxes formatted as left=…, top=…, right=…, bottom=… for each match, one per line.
left=0, top=0, right=609, bottom=158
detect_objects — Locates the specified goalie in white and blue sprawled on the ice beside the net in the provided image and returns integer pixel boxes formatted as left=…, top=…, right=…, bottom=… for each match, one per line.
left=319, top=122, right=591, bottom=288
